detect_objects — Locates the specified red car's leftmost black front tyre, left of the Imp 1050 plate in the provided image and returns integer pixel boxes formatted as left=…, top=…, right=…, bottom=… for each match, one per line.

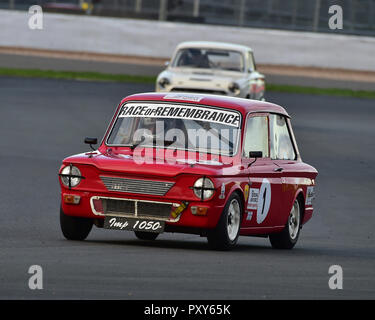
left=60, top=208, right=93, bottom=240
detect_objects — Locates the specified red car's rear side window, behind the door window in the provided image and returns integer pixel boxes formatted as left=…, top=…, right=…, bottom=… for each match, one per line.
left=269, top=114, right=296, bottom=160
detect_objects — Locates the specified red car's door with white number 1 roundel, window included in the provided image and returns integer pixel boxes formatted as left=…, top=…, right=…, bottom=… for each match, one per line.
left=242, top=113, right=281, bottom=232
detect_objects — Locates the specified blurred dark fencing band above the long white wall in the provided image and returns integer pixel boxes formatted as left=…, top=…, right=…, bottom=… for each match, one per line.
left=0, top=0, right=375, bottom=35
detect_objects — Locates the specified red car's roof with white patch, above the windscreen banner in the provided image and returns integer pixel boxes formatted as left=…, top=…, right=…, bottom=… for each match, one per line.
left=121, top=92, right=289, bottom=117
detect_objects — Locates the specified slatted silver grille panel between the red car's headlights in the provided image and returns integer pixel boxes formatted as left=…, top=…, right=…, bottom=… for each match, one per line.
left=100, top=176, right=174, bottom=196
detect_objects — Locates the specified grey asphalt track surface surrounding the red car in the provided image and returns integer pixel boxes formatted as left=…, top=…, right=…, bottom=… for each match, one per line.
left=0, top=77, right=375, bottom=300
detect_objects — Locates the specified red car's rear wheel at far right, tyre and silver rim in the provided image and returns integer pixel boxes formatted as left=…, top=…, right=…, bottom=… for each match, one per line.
left=269, top=199, right=302, bottom=249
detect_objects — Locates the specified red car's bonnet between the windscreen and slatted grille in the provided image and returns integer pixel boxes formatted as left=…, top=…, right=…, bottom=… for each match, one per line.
left=63, top=151, right=240, bottom=178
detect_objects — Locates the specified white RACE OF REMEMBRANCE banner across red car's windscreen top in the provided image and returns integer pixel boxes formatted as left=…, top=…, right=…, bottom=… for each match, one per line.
left=119, top=103, right=240, bottom=128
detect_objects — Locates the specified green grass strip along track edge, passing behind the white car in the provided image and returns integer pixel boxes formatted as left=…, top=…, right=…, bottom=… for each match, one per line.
left=0, top=68, right=375, bottom=99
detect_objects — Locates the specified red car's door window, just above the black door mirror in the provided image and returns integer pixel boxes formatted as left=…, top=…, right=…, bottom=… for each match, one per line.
left=243, top=116, right=269, bottom=158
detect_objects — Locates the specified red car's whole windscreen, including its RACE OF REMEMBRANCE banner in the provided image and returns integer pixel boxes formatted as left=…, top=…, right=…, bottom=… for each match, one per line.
left=107, top=102, right=241, bottom=156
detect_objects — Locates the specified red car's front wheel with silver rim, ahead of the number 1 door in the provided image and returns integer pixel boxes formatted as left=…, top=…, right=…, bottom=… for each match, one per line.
left=207, top=193, right=243, bottom=250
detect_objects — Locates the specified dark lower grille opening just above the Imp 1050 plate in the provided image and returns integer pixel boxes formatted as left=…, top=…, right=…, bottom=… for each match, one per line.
left=102, top=198, right=172, bottom=220
